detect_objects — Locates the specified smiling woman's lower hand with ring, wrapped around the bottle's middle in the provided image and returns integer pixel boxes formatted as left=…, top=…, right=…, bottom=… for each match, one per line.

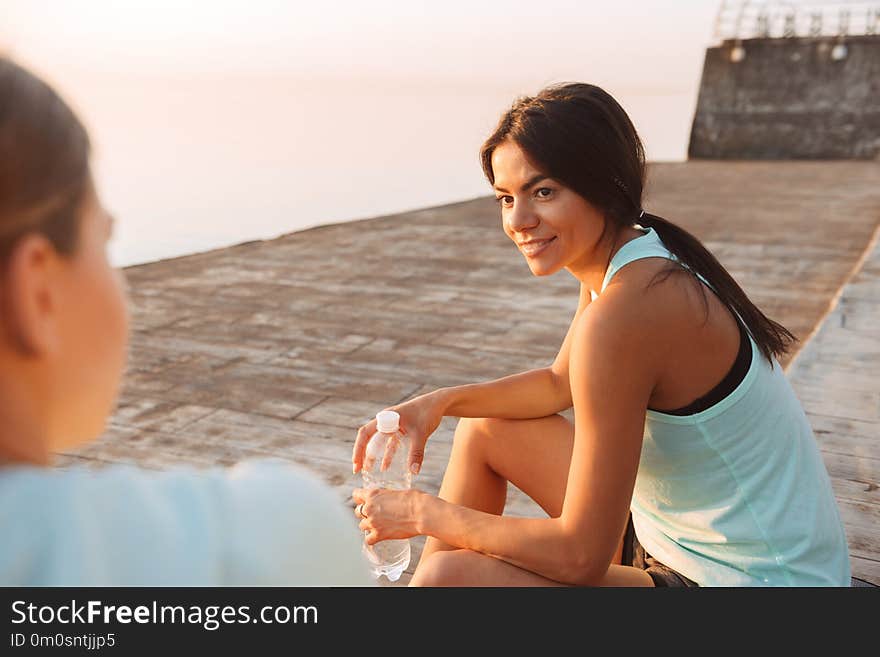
left=352, top=488, right=428, bottom=545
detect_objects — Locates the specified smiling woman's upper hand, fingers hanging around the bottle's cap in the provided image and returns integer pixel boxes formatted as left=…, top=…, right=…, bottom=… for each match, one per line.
left=351, top=390, right=446, bottom=475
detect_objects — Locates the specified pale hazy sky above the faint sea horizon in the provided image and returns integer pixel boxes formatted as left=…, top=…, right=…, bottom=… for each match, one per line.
left=0, top=0, right=719, bottom=90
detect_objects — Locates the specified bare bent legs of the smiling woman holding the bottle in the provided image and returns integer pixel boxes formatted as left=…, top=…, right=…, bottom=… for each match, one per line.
left=413, top=415, right=632, bottom=586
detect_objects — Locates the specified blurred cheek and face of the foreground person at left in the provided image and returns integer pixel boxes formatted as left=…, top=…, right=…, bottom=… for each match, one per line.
left=49, top=182, right=128, bottom=451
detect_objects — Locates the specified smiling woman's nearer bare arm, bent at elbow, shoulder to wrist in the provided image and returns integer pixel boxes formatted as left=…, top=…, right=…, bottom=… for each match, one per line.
left=415, top=288, right=662, bottom=584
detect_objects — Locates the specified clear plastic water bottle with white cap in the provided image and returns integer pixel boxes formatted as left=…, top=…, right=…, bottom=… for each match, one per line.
left=362, top=411, right=412, bottom=582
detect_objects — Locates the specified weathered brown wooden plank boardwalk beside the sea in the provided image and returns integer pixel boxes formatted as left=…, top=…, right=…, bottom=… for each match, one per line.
left=58, top=162, right=880, bottom=583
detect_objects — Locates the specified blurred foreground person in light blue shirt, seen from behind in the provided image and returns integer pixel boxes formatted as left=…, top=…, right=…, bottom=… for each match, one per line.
left=0, top=57, right=371, bottom=586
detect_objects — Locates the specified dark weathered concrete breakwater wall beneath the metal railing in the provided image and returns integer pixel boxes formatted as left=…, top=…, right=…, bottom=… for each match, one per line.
left=688, top=34, right=880, bottom=160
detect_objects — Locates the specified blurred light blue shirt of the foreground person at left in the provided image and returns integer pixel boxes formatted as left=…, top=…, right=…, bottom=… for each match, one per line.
left=0, top=461, right=373, bottom=586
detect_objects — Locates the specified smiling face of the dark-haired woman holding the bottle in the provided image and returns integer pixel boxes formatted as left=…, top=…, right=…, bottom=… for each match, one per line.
left=492, top=139, right=605, bottom=280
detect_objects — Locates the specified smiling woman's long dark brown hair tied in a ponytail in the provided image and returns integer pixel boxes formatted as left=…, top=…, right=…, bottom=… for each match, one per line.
left=480, top=83, right=796, bottom=363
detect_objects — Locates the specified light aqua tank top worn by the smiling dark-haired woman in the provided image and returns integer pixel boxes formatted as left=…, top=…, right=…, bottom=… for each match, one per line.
left=600, top=226, right=850, bottom=586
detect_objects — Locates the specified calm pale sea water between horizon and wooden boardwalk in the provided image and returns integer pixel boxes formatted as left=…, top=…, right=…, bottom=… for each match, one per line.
left=54, top=73, right=696, bottom=265
